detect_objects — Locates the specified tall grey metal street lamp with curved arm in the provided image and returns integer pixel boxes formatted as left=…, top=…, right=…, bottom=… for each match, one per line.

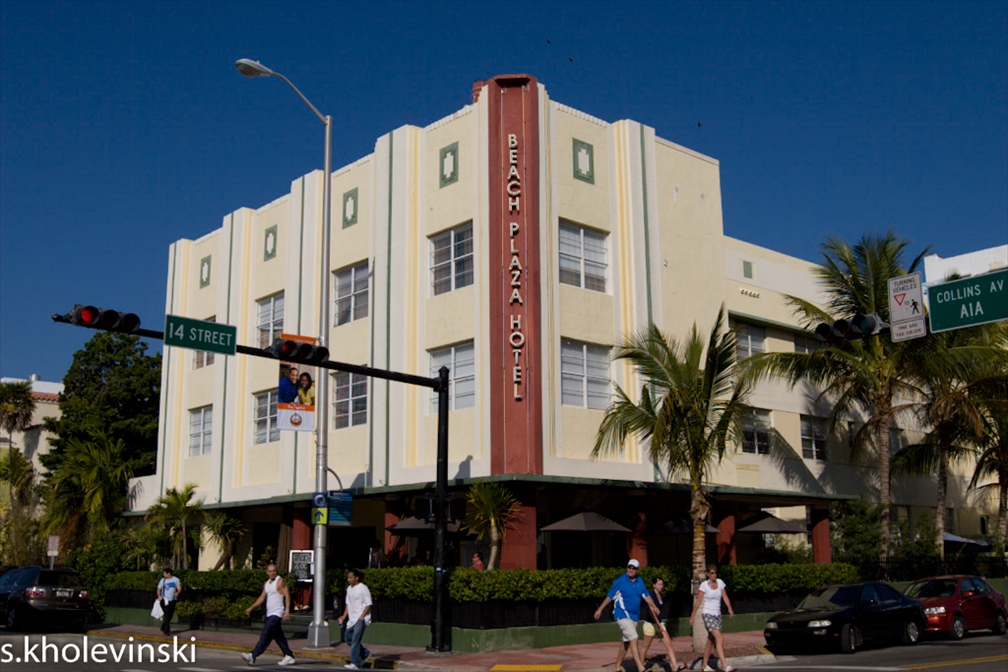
left=235, top=58, right=333, bottom=648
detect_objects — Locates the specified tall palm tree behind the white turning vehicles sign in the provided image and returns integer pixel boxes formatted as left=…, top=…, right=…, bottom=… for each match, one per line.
left=746, top=231, right=933, bottom=561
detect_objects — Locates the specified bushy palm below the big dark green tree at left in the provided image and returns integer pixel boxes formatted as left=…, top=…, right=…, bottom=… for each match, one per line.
left=45, top=432, right=133, bottom=545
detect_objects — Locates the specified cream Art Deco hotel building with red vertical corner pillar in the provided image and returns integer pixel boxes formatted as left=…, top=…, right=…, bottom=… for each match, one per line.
left=134, top=75, right=995, bottom=567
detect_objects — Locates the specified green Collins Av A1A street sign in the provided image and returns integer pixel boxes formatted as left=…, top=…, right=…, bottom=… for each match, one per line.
left=927, top=269, right=1008, bottom=332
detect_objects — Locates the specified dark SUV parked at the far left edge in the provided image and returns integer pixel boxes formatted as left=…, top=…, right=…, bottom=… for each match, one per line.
left=0, top=565, right=91, bottom=630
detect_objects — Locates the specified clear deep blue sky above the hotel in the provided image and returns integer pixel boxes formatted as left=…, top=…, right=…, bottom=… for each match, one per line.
left=0, top=0, right=1008, bottom=381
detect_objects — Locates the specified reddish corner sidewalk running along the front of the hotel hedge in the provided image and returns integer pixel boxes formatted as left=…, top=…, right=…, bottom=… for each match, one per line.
left=88, top=625, right=774, bottom=672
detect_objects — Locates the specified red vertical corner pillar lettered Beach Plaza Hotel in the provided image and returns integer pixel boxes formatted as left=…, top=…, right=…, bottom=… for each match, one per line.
left=487, top=75, right=542, bottom=474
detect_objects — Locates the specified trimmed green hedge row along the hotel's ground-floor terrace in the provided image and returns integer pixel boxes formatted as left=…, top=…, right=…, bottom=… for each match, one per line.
left=106, top=563, right=858, bottom=602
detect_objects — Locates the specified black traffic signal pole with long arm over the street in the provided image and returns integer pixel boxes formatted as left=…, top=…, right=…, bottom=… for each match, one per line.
left=52, top=313, right=452, bottom=653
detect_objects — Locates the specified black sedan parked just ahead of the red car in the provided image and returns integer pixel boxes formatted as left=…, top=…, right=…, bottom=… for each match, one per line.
left=763, top=583, right=927, bottom=653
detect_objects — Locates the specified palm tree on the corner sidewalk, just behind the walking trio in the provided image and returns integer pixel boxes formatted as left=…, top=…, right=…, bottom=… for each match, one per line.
left=592, top=306, right=749, bottom=592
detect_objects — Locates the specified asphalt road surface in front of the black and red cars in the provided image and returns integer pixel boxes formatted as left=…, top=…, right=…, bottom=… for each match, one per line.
left=747, top=634, right=1008, bottom=672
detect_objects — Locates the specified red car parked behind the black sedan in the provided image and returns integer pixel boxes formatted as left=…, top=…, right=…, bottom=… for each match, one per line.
left=905, top=576, right=1008, bottom=640
